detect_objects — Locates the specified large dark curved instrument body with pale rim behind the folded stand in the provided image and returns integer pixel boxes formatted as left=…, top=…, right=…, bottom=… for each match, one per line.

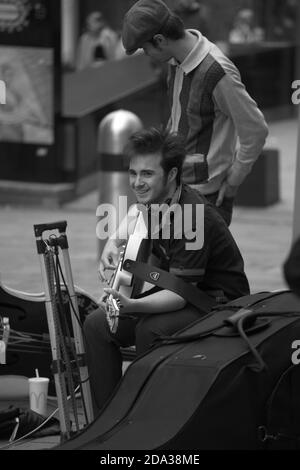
left=0, top=282, right=98, bottom=394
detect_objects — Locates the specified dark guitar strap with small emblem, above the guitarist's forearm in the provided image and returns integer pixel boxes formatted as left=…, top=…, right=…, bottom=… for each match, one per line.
left=123, top=259, right=217, bottom=313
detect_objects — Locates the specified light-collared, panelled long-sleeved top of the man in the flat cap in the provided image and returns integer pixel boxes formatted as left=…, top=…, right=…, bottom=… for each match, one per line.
left=168, top=30, right=268, bottom=194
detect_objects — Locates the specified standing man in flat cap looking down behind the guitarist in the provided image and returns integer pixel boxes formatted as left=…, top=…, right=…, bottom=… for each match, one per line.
left=122, top=0, right=268, bottom=225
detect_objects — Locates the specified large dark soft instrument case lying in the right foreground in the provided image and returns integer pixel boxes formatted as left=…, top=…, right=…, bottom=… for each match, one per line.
left=54, top=291, right=300, bottom=451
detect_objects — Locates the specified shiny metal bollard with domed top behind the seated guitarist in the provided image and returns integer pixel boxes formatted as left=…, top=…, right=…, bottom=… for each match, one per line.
left=97, top=110, right=143, bottom=255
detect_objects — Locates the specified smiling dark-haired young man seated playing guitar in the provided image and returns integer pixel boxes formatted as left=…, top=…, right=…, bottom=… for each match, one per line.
left=84, top=129, right=249, bottom=413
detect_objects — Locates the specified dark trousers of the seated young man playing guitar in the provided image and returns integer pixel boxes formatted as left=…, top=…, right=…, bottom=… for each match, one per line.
left=83, top=304, right=203, bottom=416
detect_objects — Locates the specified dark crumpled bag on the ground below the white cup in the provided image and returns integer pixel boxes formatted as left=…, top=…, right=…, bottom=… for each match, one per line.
left=0, top=406, right=60, bottom=440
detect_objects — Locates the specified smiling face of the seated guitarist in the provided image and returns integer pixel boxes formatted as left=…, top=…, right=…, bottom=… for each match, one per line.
left=129, top=153, right=172, bottom=204
